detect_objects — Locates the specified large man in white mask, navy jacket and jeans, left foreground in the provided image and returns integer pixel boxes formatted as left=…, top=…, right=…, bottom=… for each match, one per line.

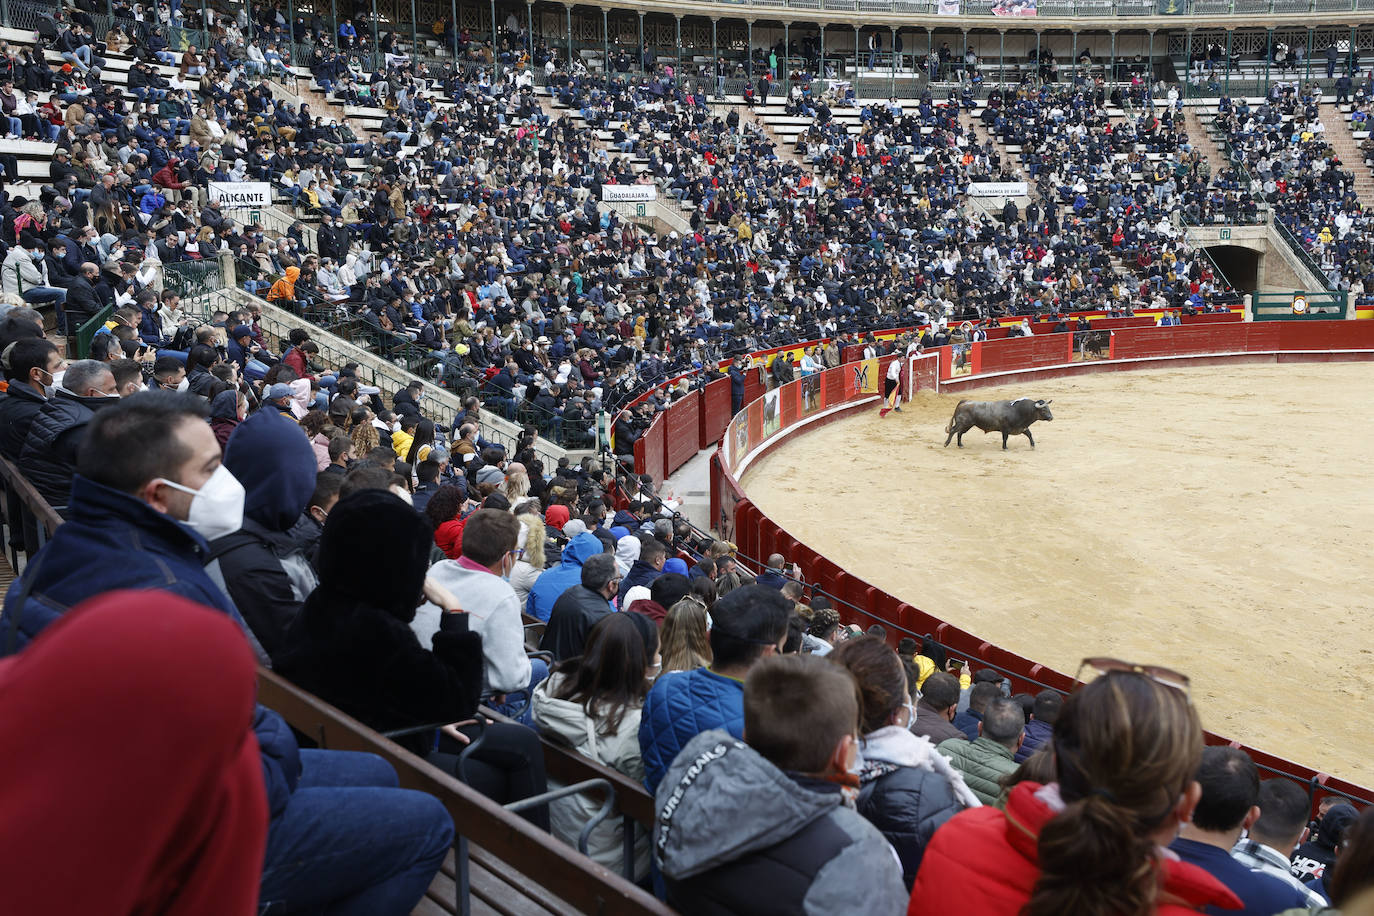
left=0, top=391, right=452, bottom=909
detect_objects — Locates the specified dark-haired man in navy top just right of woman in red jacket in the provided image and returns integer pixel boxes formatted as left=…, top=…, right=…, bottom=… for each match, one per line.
left=1169, top=747, right=1307, bottom=916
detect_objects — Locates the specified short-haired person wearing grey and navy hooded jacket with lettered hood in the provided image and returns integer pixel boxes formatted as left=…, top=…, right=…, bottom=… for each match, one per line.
left=654, top=656, right=908, bottom=913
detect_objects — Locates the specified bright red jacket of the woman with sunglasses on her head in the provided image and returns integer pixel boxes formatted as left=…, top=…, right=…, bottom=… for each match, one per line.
left=907, top=783, right=1241, bottom=916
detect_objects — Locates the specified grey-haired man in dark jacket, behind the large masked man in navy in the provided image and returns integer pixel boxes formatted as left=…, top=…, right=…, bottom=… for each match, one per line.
left=19, top=360, right=120, bottom=509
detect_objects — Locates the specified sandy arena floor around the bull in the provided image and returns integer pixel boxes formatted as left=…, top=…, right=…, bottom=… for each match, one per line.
left=745, top=363, right=1374, bottom=786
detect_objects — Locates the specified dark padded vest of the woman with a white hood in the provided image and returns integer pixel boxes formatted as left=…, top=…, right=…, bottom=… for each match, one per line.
left=856, top=764, right=963, bottom=887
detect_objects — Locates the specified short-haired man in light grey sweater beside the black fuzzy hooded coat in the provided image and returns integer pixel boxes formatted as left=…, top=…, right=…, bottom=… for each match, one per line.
left=411, top=508, right=533, bottom=694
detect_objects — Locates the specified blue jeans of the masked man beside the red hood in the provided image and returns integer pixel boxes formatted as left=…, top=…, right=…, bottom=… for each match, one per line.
left=260, top=750, right=453, bottom=916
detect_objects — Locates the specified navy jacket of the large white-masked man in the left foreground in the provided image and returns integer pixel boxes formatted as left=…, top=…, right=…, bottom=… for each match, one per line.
left=0, top=474, right=301, bottom=817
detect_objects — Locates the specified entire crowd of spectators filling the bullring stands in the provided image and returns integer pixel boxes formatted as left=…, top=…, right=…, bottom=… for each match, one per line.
left=0, top=4, right=1374, bottom=916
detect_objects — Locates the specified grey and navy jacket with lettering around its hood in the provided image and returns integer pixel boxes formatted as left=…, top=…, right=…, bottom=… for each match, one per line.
left=654, top=731, right=908, bottom=916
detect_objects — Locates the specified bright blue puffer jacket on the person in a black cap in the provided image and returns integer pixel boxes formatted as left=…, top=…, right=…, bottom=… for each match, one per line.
left=639, top=667, right=745, bottom=794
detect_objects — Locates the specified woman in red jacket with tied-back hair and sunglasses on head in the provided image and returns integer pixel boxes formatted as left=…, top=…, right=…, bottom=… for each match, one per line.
left=908, top=659, right=1241, bottom=916
